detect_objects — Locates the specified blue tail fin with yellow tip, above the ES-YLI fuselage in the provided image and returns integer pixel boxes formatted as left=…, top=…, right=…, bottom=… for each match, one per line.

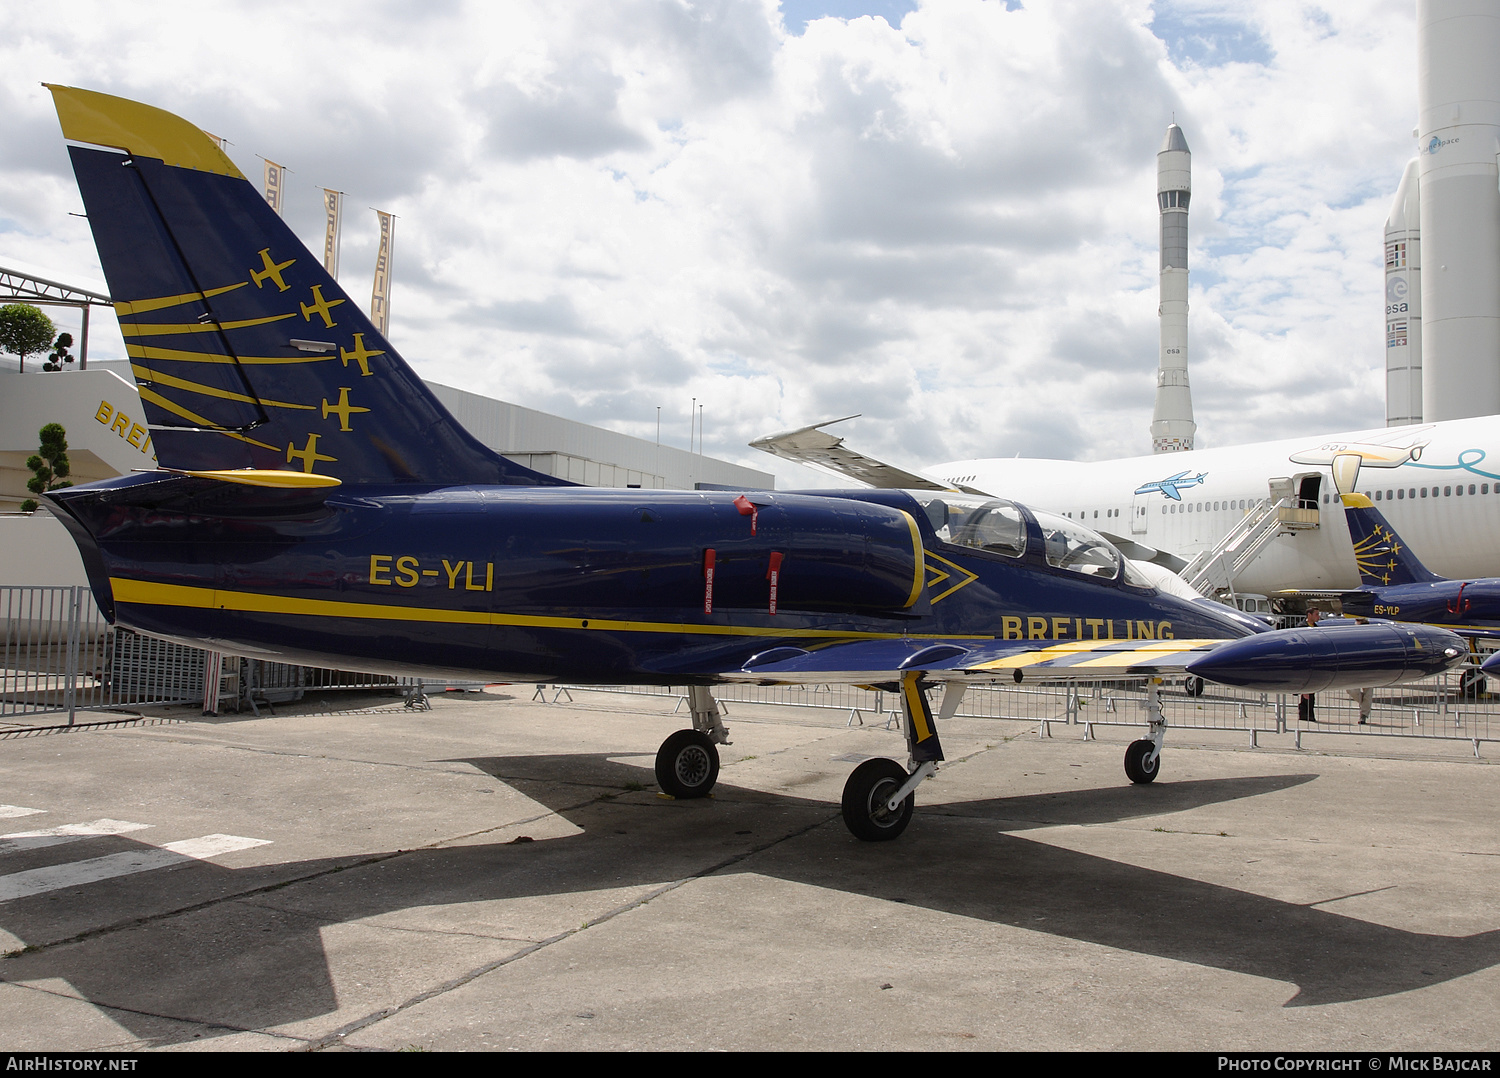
left=48, top=85, right=561, bottom=486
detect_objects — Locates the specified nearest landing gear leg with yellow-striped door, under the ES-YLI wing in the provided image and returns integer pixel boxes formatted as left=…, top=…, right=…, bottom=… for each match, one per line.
left=843, top=673, right=965, bottom=843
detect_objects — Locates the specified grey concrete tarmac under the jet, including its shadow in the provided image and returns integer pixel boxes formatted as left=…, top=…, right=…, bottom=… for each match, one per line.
left=0, top=687, right=1500, bottom=1051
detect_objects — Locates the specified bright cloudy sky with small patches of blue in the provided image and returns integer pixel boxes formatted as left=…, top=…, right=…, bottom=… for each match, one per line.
left=0, top=0, right=1416, bottom=486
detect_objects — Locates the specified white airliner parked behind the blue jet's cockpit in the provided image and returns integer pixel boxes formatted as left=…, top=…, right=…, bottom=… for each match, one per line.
left=752, top=415, right=1500, bottom=595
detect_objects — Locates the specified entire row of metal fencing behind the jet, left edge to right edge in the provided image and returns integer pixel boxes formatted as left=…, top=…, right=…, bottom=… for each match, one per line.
left=11, top=586, right=1500, bottom=756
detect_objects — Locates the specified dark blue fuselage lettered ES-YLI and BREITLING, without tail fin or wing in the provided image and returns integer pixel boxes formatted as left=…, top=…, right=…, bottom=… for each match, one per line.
left=51, top=474, right=1256, bottom=684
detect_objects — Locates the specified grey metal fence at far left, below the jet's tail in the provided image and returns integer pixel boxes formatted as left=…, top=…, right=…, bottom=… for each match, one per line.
left=0, top=585, right=483, bottom=723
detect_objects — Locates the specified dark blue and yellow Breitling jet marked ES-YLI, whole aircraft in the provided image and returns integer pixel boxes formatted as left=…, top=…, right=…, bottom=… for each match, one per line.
left=35, top=85, right=1464, bottom=840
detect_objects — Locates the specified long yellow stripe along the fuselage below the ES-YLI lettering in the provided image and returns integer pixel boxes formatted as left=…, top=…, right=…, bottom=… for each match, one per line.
left=110, top=577, right=990, bottom=640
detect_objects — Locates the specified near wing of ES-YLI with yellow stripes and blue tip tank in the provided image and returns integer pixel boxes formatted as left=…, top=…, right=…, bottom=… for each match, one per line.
left=722, top=622, right=1469, bottom=693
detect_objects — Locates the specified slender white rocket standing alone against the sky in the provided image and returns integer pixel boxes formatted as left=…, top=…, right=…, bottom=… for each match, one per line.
left=1151, top=124, right=1199, bottom=453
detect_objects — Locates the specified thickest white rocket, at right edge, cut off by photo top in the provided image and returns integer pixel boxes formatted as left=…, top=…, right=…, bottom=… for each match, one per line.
left=1404, top=0, right=1500, bottom=423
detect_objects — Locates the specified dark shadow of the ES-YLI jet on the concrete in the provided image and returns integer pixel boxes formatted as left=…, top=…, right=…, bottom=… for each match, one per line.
left=0, top=756, right=1500, bottom=1044
